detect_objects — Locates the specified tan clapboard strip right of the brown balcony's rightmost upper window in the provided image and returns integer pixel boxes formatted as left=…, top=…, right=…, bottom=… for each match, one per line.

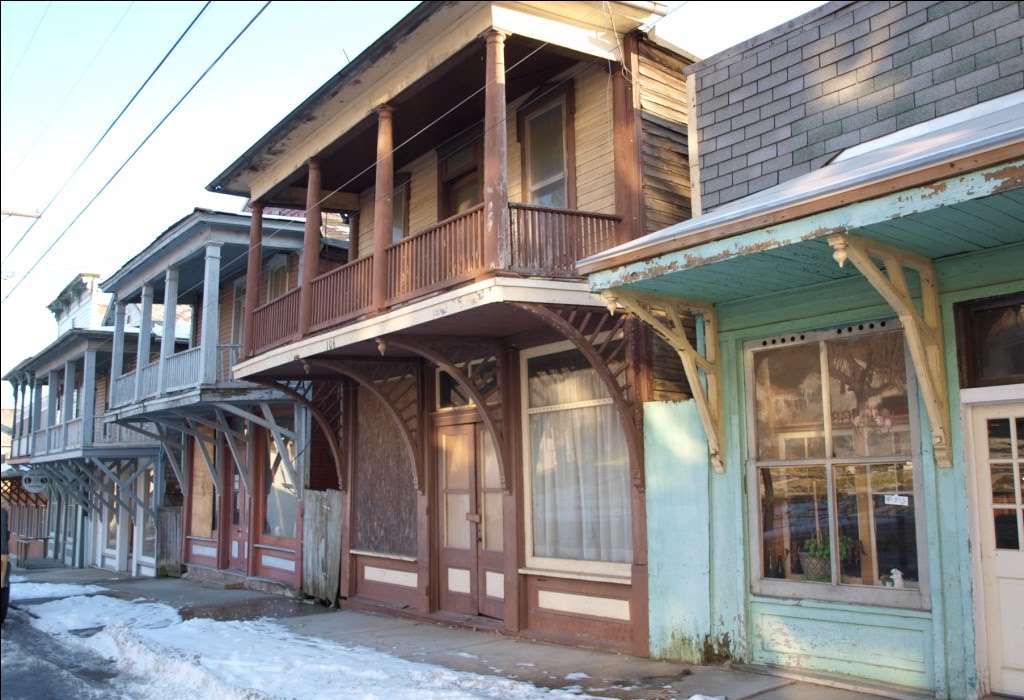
left=573, top=67, right=615, bottom=214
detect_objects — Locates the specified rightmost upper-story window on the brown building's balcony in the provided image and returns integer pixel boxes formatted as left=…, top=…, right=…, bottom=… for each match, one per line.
left=517, top=83, right=575, bottom=209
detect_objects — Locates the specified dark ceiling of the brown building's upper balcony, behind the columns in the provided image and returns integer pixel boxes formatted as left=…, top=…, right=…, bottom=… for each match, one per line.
left=265, top=36, right=593, bottom=205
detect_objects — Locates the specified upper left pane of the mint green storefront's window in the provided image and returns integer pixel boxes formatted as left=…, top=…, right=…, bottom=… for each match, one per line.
left=754, top=344, right=825, bottom=460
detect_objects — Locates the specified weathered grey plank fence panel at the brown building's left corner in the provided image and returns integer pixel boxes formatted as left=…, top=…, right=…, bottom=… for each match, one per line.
left=302, top=489, right=344, bottom=603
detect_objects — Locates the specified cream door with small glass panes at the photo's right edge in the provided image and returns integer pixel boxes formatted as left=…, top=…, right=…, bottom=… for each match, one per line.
left=973, top=403, right=1024, bottom=696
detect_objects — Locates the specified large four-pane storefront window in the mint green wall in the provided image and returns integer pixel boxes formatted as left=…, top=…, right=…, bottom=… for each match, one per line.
left=746, top=320, right=926, bottom=606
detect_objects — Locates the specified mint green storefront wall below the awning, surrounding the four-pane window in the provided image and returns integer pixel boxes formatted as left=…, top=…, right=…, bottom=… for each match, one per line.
left=645, top=245, right=1024, bottom=698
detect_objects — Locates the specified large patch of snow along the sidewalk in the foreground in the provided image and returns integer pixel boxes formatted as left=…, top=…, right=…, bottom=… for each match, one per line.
left=30, top=596, right=582, bottom=700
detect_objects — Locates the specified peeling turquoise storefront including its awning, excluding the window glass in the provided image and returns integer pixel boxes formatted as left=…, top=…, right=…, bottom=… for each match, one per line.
left=584, top=134, right=1024, bottom=698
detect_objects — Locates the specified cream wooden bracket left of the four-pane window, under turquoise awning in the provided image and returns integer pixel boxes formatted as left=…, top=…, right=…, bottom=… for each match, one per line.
left=601, top=290, right=725, bottom=474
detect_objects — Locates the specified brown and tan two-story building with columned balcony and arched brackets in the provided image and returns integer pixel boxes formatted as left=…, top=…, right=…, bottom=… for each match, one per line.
left=209, top=2, right=690, bottom=654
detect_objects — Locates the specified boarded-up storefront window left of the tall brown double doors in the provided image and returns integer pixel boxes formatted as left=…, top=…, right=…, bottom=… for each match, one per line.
left=353, top=390, right=416, bottom=557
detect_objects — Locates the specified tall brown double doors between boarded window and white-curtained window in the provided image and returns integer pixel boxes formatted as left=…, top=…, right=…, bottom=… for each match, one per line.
left=437, top=424, right=505, bottom=619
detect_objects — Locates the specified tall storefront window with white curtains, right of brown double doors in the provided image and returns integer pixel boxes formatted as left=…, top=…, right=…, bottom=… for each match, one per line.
left=522, top=343, right=633, bottom=576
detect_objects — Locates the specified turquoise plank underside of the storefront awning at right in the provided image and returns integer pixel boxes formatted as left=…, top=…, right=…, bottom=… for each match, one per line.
left=626, top=183, right=1024, bottom=304
